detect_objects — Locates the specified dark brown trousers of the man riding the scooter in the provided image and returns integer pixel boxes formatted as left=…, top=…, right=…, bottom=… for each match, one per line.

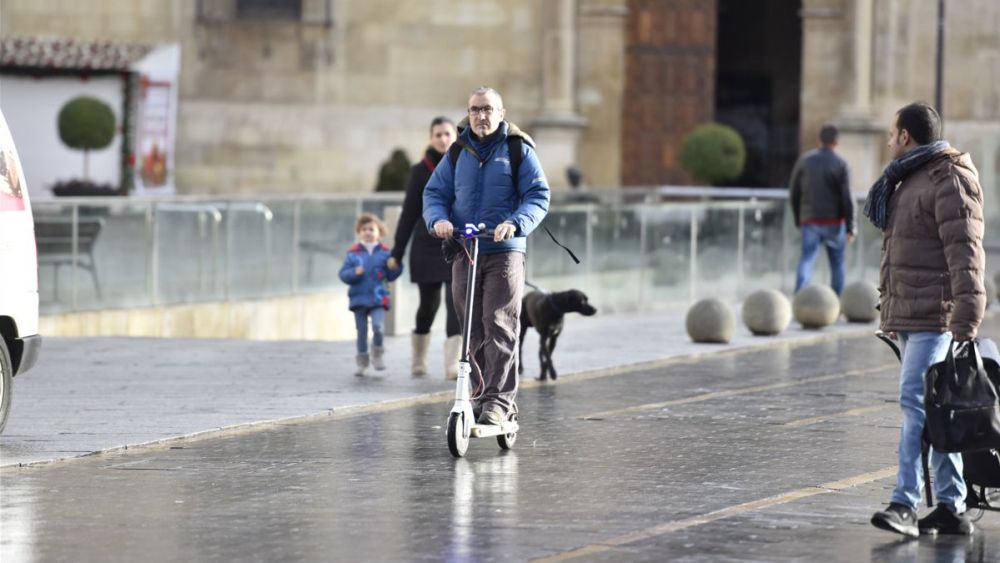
left=451, top=252, right=524, bottom=412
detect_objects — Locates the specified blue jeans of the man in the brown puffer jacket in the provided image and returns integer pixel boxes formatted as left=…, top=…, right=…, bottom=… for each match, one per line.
left=892, top=332, right=965, bottom=514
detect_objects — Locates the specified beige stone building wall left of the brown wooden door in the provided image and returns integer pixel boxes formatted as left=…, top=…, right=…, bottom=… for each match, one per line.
left=0, top=0, right=625, bottom=193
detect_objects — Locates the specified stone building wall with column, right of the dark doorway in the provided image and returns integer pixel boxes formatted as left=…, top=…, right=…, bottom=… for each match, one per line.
left=800, top=0, right=1000, bottom=197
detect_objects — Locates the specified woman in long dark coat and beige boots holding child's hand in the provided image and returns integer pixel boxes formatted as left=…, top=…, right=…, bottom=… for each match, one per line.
left=389, top=117, right=462, bottom=379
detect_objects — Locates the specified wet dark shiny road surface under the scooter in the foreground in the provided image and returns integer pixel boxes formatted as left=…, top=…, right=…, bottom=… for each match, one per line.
left=0, top=319, right=1000, bottom=563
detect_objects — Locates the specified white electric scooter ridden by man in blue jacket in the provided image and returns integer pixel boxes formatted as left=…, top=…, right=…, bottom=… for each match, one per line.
left=448, top=224, right=518, bottom=457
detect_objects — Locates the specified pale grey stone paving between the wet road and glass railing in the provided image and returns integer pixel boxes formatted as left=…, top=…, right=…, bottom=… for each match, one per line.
left=0, top=313, right=888, bottom=466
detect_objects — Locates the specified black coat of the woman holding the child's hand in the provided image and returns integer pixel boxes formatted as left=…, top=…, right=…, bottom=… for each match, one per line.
left=392, top=148, right=451, bottom=283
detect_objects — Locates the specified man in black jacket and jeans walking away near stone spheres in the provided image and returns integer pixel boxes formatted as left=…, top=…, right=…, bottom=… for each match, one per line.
left=789, top=125, right=854, bottom=295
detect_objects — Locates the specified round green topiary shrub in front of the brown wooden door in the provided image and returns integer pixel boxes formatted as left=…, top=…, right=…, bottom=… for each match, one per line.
left=681, top=123, right=747, bottom=185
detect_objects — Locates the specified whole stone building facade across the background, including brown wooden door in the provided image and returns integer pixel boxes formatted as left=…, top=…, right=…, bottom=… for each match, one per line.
left=0, top=0, right=1000, bottom=199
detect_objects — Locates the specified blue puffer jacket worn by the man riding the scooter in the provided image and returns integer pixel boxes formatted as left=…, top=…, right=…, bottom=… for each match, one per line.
left=424, top=121, right=549, bottom=254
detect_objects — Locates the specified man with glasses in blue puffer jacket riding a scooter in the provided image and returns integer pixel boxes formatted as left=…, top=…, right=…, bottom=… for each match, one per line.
left=424, top=88, right=549, bottom=424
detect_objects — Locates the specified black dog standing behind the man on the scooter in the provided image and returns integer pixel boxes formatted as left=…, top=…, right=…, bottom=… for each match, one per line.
left=517, top=289, right=597, bottom=381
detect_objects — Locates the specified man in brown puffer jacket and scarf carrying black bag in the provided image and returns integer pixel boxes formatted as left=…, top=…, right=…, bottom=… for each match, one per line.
left=865, top=103, right=986, bottom=536
